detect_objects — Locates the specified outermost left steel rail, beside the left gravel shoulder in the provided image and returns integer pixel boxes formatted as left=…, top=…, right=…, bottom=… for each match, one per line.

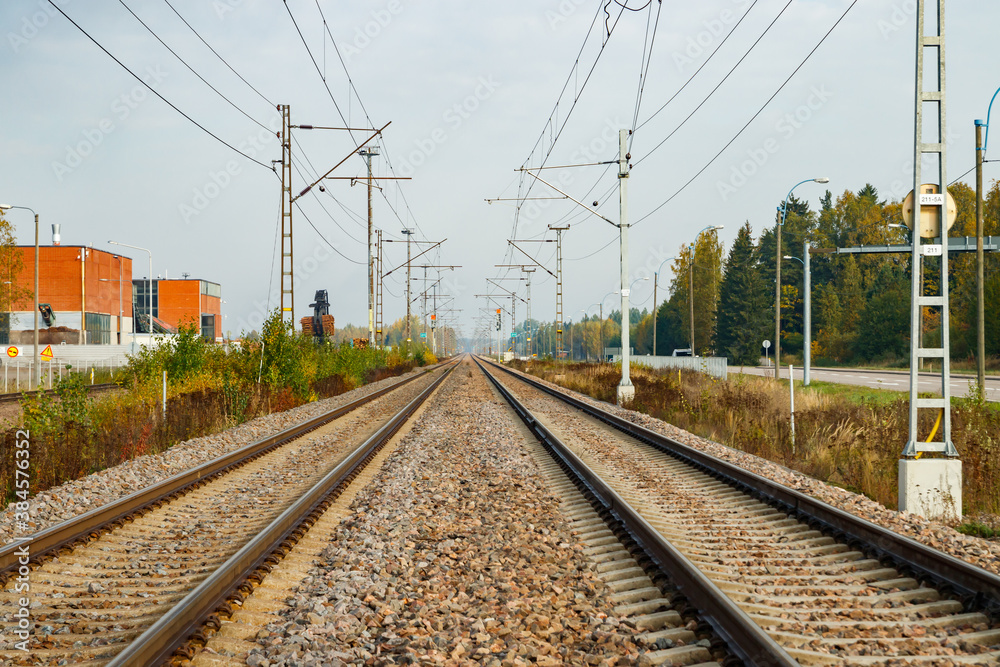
left=0, top=362, right=446, bottom=583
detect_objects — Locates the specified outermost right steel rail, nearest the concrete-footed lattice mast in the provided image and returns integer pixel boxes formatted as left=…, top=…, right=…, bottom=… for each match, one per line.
left=487, top=362, right=1000, bottom=618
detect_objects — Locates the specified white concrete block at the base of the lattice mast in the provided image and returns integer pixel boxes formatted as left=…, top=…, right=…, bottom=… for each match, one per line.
left=899, top=459, right=962, bottom=520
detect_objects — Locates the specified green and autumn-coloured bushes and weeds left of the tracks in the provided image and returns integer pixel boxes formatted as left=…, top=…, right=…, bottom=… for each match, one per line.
left=0, top=328, right=436, bottom=502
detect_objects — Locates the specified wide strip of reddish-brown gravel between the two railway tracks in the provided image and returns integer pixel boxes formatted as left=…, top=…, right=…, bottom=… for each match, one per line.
left=247, top=361, right=640, bottom=667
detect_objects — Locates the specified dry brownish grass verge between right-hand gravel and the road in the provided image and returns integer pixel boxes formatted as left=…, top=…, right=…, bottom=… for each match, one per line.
left=513, top=362, right=1000, bottom=514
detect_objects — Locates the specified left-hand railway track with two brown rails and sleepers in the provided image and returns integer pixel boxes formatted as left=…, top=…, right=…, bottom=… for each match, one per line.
left=0, top=368, right=450, bottom=665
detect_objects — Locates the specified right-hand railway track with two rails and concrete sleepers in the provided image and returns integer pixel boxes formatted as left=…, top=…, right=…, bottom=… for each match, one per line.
left=481, top=364, right=1000, bottom=665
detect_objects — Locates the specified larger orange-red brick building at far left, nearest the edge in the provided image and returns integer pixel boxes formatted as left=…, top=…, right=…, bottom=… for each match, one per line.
left=0, top=245, right=132, bottom=344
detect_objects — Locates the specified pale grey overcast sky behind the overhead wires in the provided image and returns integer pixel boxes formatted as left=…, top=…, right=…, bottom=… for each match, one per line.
left=0, top=0, right=1000, bottom=344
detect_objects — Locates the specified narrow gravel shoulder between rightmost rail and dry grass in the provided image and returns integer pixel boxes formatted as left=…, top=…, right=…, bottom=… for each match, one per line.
left=504, top=362, right=1000, bottom=574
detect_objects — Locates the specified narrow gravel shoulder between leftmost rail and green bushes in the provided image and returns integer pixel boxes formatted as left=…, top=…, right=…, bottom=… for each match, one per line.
left=0, top=369, right=436, bottom=544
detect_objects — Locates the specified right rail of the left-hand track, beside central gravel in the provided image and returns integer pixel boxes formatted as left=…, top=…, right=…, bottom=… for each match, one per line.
left=108, top=365, right=455, bottom=667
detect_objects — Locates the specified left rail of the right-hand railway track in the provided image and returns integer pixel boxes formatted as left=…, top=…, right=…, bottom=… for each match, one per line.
left=476, top=359, right=799, bottom=667
